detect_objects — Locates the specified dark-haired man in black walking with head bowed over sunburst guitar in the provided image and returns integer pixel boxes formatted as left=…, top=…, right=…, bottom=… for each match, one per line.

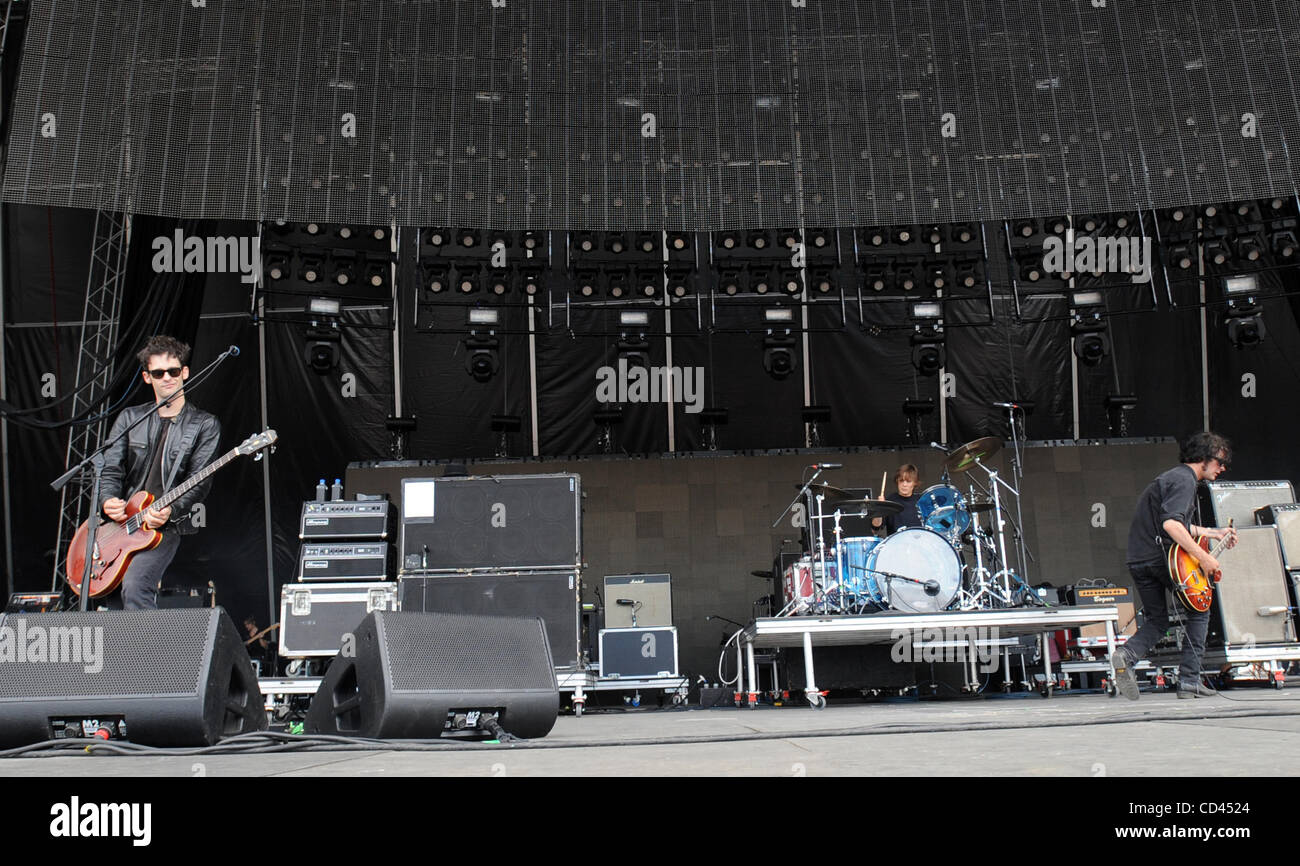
left=1110, top=432, right=1236, bottom=701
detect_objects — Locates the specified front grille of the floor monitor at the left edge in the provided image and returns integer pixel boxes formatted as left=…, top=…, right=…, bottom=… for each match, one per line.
left=0, top=610, right=208, bottom=701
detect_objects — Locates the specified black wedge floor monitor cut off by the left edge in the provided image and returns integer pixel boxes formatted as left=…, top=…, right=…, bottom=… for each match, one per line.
left=0, top=607, right=267, bottom=748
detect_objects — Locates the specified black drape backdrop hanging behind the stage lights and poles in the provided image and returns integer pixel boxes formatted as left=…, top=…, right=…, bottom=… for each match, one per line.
left=4, top=205, right=1300, bottom=623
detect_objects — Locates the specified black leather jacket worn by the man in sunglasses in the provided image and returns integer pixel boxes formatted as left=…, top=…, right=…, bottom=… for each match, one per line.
left=99, top=400, right=221, bottom=536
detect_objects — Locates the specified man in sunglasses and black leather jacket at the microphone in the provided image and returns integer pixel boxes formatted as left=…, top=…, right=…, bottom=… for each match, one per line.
left=100, top=335, right=221, bottom=610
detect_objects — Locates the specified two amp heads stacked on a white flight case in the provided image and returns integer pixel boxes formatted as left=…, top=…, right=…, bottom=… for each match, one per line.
left=280, top=482, right=398, bottom=658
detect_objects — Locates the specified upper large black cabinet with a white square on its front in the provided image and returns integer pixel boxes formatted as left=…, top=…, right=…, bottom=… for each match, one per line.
left=399, top=473, right=582, bottom=575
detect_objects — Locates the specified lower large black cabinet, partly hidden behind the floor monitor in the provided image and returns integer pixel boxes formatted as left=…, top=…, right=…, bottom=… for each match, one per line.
left=398, top=571, right=581, bottom=668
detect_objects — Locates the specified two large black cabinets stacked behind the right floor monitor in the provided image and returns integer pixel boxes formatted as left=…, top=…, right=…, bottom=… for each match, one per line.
left=398, top=473, right=584, bottom=670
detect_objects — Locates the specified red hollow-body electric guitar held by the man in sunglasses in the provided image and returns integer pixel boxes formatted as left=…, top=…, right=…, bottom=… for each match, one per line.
left=65, top=430, right=277, bottom=598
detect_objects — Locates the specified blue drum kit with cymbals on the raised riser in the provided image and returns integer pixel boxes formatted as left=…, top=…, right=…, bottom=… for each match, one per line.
left=777, top=437, right=1039, bottom=616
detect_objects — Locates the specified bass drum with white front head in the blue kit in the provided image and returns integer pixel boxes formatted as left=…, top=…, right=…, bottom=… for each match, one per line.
left=867, top=529, right=962, bottom=614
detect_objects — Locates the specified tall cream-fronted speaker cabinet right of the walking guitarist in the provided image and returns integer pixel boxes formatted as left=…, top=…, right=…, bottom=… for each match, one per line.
left=1208, top=527, right=1295, bottom=646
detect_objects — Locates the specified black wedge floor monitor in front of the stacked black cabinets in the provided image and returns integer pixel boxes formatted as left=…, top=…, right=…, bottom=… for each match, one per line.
left=306, top=611, right=560, bottom=740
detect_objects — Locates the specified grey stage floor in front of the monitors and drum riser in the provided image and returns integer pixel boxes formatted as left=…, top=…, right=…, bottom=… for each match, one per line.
left=0, top=687, right=1300, bottom=778
